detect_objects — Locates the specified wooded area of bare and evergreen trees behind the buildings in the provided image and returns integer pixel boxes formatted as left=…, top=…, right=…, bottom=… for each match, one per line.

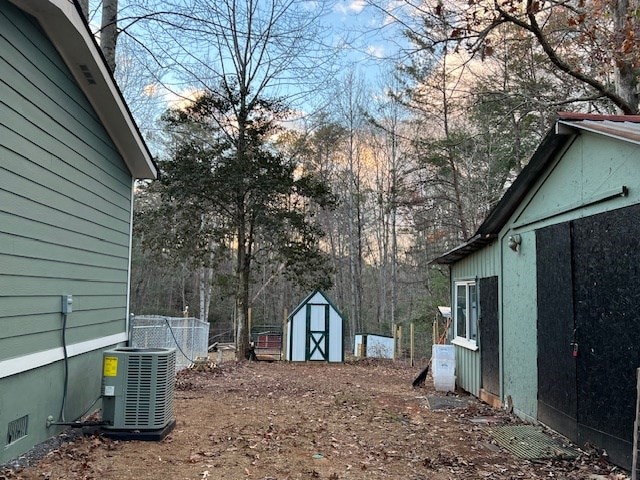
left=86, top=0, right=640, bottom=354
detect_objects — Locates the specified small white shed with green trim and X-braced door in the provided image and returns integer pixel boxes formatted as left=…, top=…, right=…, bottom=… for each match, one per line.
left=285, top=290, right=344, bottom=362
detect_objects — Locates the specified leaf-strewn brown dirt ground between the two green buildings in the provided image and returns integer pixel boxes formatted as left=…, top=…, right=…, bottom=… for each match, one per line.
left=0, top=360, right=628, bottom=480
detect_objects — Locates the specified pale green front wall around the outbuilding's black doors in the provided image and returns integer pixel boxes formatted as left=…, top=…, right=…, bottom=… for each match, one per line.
left=500, top=133, right=640, bottom=419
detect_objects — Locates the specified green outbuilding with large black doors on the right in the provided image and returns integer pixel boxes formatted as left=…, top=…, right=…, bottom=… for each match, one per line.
left=435, top=114, right=640, bottom=468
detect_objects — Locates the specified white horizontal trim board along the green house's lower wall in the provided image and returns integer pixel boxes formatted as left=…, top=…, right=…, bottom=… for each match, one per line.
left=0, top=332, right=128, bottom=378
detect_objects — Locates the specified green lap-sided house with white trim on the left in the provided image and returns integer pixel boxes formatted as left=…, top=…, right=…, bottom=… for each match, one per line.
left=0, top=0, right=156, bottom=463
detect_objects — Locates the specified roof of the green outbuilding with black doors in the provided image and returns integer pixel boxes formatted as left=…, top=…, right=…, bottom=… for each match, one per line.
left=430, top=112, right=640, bottom=265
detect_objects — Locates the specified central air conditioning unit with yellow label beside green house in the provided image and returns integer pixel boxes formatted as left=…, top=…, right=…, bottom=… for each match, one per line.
left=102, top=347, right=176, bottom=432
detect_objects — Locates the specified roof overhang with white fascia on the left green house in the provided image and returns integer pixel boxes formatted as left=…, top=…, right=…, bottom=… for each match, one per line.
left=10, top=0, right=158, bottom=178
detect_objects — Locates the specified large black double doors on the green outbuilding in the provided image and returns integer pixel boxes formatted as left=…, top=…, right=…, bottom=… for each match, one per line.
left=536, top=206, right=640, bottom=467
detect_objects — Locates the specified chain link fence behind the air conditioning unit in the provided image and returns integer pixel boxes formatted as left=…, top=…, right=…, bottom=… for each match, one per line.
left=129, top=315, right=209, bottom=371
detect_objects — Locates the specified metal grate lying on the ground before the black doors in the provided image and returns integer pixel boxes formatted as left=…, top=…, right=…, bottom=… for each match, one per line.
left=481, top=425, right=578, bottom=460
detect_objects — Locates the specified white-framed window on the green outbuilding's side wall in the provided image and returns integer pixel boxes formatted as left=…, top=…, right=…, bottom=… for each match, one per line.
left=453, top=281, right=478, bottom=349
